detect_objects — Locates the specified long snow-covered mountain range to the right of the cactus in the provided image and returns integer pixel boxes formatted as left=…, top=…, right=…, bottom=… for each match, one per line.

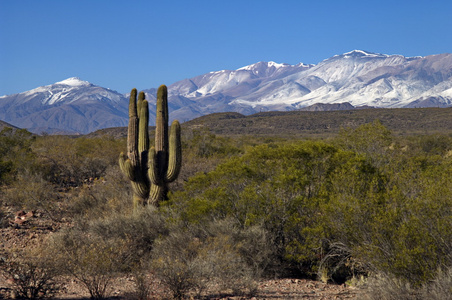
left=162, top=50, right=452, bottom=114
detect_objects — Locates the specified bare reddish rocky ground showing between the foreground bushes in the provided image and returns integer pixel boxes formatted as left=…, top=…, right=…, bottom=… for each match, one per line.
left=0, top=212, right=359, bottom=300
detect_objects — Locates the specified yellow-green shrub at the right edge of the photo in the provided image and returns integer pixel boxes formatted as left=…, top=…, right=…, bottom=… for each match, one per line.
left=324, top=154, right=452, bottom=286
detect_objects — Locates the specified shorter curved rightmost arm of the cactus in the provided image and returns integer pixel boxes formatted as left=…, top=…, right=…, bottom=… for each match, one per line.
left=165, top=120, right=182, bottom=182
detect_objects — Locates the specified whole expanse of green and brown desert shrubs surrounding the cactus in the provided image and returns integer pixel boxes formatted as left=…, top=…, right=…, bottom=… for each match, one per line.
left=0, top=122, right=452, bottom=299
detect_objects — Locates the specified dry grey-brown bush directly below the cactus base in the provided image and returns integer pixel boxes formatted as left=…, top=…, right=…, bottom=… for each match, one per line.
left=48, top=204, right=168, bottom=299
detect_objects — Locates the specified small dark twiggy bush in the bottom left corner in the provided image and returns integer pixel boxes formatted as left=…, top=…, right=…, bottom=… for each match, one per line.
left=0, top=251, right=60, bottom=299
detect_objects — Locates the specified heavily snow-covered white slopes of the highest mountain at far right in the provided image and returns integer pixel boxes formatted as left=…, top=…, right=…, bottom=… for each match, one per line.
left=226, top=50, right=452, bottom=109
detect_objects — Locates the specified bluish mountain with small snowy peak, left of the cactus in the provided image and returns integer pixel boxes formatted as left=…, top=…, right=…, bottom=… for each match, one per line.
left=0, top=77, right=128, bottom=133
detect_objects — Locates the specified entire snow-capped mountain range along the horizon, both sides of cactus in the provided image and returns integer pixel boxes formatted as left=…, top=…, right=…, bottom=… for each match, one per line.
left=0, top=50, right=452, bottom=133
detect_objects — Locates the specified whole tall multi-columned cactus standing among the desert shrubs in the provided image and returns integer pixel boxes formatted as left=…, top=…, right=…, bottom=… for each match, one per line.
left=119, top=85, right=182, bottom=209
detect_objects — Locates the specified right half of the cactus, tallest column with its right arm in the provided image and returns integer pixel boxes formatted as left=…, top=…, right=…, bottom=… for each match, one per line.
left=149, top=85, right=182, bottom=204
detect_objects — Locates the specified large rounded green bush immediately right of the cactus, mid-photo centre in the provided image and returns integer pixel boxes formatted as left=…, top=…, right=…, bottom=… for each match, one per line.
left=170, top=141, right=377, bottom=273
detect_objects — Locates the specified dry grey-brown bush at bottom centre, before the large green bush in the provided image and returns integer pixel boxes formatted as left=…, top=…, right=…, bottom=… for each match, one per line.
left=151, top=219, right=258, bottom=299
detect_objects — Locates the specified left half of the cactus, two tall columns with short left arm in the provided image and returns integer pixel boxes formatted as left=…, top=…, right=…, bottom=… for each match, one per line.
left=119, top=89, right=150, bottom=209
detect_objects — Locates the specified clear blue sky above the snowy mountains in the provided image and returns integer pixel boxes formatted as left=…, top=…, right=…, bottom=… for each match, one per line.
left=0, top=0, right=452, bottom=95
